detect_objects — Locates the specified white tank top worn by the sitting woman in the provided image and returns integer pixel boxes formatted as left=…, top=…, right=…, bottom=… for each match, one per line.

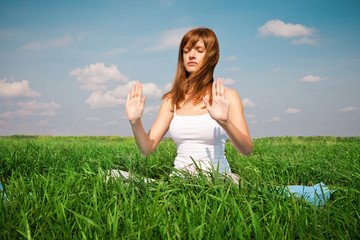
left=169, top=109, right=231, bottom=173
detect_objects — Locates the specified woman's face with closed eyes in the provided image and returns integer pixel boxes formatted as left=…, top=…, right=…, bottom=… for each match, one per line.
left=183, top=39, right=206, bottom=74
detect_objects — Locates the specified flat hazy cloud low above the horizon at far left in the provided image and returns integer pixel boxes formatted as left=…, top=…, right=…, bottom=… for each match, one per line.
left=0, top=101, right=61, bottom=118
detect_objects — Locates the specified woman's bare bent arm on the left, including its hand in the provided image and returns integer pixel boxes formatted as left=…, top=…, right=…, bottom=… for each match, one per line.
left=125, top=82, right=174, bottom=155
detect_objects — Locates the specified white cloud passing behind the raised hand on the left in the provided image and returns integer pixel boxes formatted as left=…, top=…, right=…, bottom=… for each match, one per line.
left=85, top=81, right=162, bottom=109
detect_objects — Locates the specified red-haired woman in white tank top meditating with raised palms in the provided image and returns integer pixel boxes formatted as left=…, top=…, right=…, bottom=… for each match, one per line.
left=126, top=28, right=252, bottom=178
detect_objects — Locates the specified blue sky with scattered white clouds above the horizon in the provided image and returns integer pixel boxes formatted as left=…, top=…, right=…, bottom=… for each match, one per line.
left=0, top=0, right=360, bottom=138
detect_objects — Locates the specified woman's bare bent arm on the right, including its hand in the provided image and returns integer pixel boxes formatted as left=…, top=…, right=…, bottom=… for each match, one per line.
left=204, top=79, right=253, bottom=156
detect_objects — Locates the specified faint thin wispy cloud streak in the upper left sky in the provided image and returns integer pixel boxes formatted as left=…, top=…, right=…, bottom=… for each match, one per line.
left=21, top=33, right=84, bottom=51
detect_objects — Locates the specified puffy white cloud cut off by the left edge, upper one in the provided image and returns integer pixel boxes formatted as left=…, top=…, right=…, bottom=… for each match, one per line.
left=0, top=78, right=41, bottom=98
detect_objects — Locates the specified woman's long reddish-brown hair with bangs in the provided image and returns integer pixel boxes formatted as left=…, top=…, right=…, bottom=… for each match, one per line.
left=162, top=27, right=220, bottom=108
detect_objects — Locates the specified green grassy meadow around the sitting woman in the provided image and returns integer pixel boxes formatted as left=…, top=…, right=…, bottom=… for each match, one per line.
left=0, top=136, right=360, bottom=239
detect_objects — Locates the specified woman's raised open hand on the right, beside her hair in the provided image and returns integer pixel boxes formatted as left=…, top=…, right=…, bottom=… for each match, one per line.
left=203, top=78, right=230, bottom=122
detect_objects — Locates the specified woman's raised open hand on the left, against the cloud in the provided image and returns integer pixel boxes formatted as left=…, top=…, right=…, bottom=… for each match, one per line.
left=125, top=82, right=146, bottom=124
